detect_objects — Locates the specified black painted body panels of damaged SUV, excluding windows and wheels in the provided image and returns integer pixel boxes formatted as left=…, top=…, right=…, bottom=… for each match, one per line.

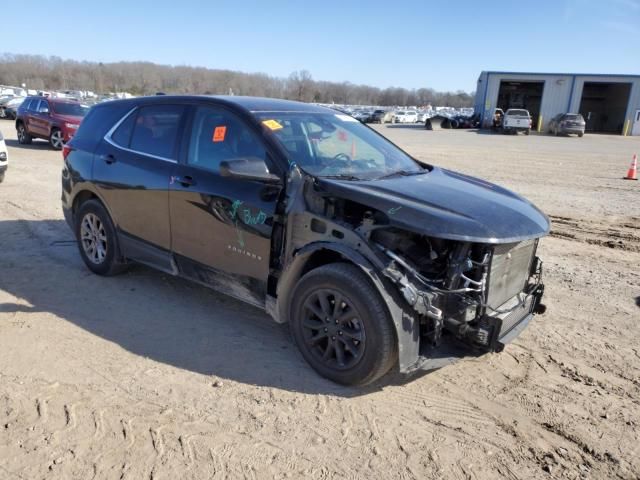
left=62, top=96, right=549, bottom=371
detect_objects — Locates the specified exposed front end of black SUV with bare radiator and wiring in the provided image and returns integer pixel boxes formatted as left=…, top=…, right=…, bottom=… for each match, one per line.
left=371, top=229, right=541, bottom=350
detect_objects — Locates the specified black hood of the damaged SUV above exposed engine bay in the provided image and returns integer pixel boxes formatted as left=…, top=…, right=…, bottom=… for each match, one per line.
left=317, top=167, right=550, bottom=243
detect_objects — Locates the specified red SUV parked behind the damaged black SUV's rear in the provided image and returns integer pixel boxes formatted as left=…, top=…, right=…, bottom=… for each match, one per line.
left=16, top=97, right=88, bottom=150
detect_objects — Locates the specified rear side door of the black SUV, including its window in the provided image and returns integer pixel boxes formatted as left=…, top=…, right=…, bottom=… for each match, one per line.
left=93, top=104, right=186, bottom=272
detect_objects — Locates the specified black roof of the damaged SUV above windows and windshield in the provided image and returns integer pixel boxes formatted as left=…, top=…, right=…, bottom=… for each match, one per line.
left=99, top=95, right=335, bottom=114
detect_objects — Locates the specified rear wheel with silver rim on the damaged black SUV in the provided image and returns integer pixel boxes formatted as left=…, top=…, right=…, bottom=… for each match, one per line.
left=75, top=200, right=125, bottom=276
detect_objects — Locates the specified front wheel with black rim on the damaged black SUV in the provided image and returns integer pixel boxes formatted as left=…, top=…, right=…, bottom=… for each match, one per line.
left=289, top=263, right=397, bottom=385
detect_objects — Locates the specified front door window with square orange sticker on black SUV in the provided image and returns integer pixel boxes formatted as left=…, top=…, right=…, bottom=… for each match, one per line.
left=187, top=107, right=266, bottom=172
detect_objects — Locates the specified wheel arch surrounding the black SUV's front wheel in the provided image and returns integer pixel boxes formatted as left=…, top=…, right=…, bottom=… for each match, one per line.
left=268, top=242, right=420, bottom=371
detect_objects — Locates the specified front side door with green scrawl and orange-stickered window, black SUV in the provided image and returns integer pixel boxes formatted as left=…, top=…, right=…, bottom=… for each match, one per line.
left=169, top=105, right=280, bottom=306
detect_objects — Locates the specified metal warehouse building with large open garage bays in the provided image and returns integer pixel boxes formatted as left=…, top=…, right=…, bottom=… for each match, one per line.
left=475, top=72, right=640, bottom=135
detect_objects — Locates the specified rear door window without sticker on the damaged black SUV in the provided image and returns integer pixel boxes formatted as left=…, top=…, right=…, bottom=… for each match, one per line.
left=129, top=105, right=184, bottom=160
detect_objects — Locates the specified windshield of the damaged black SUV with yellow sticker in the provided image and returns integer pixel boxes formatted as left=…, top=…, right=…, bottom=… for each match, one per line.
left=256, top=112, right=424, bottom=180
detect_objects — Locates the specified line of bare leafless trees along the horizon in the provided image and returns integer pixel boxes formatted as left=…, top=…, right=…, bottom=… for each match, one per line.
left=0, top=53, right=473, bottom=108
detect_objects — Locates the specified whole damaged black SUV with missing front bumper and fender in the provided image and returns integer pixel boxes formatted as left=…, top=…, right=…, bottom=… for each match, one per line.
left=62, top=96, right=549, bottom=385
